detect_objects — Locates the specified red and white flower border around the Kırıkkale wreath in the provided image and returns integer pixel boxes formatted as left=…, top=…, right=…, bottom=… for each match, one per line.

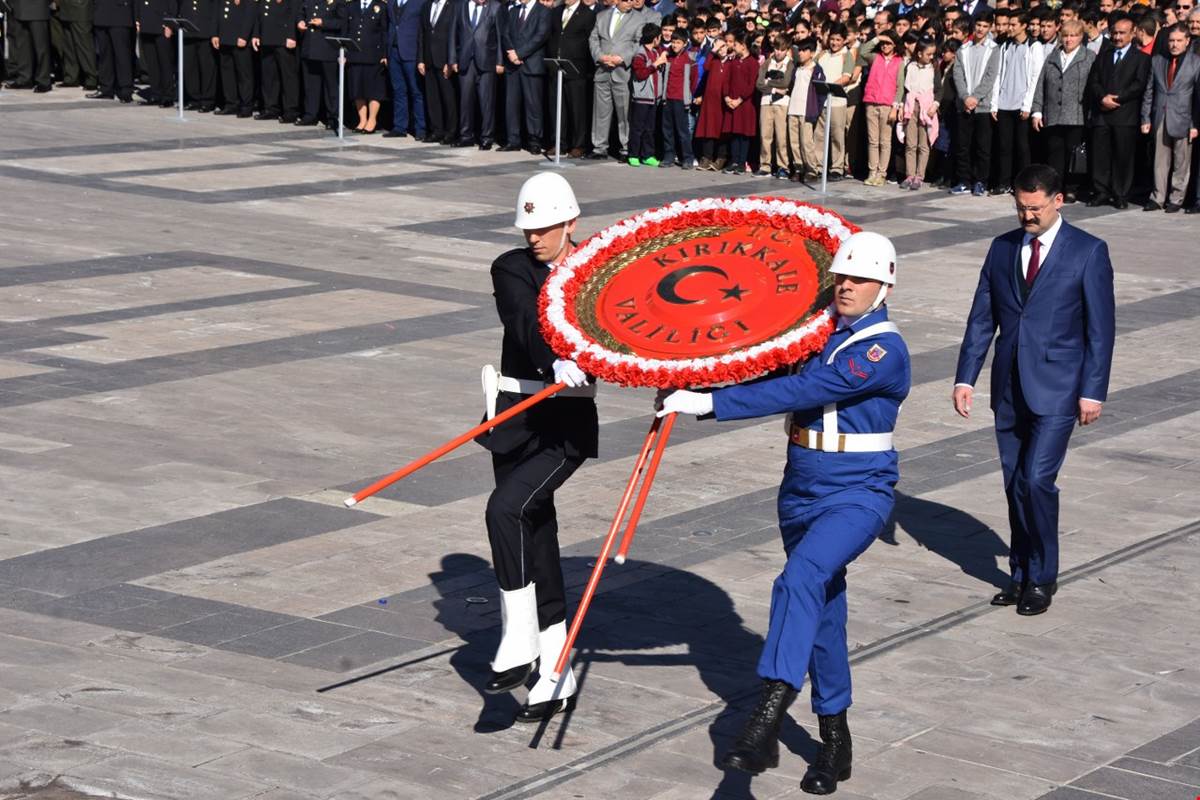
left=538, top=197, right=859, bottom=389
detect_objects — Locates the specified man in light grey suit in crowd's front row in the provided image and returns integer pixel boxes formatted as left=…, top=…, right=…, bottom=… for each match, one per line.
left=588, top=0, right=642, bottom=161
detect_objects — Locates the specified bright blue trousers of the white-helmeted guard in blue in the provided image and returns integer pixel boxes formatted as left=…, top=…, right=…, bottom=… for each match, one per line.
left=758, top=505, right=884, bottom=715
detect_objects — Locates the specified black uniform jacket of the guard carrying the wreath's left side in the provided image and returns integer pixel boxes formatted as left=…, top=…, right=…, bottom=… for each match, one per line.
left=476, top=248, right=600, bottom=458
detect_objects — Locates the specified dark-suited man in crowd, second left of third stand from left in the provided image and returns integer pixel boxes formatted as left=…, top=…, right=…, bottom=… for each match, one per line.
left=450, top=0, right=505, bottom=150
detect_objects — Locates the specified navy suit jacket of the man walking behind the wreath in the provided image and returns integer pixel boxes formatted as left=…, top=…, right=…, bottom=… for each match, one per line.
left=954, top=219, right=1116, bottom=415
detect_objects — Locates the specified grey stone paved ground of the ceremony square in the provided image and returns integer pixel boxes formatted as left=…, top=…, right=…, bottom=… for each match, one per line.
left=0, top=91, right=1200, bottom=800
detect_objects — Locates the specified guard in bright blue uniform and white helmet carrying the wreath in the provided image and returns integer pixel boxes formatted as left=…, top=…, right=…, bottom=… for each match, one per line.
left=659, top=231, right=911, bottom=794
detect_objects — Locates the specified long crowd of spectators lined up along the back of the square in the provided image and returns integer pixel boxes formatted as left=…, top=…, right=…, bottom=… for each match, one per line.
left=0, top=0, right=1200, bottom=213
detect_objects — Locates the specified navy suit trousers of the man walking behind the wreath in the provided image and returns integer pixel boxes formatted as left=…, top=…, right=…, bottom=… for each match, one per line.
left=996, top=366, right=1075, bottom=585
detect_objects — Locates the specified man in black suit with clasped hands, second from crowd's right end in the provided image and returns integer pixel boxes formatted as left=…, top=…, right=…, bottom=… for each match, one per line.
left=1087, top=13, right=1150, bottom=209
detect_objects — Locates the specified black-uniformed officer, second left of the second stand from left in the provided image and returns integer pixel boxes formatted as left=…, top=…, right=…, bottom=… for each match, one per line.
left=251, top=0, right=300, bottom=124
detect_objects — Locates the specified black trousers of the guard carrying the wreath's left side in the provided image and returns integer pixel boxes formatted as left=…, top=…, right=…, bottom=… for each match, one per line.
left=485, top=446, right=583, bottom=630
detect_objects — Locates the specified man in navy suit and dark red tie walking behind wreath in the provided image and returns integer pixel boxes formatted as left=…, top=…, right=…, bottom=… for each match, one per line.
left=954, top=164, right=1116, bottom=616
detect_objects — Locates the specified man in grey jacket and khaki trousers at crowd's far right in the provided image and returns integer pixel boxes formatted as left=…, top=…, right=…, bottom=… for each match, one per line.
left=1141, top=24, right=1200, bottom=213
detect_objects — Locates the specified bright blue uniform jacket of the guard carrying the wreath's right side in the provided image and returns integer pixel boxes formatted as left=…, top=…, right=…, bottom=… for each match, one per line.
left=713, top=306, right=912, bottom=523
